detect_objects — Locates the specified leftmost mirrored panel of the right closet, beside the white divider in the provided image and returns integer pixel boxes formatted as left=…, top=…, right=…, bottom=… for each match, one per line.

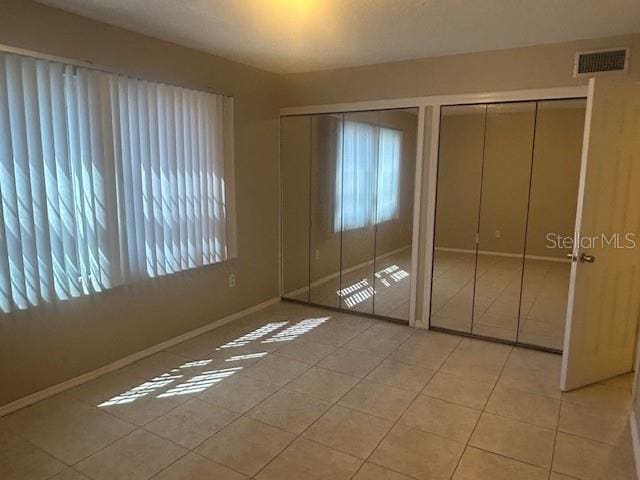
left=431, top=105, right=487, bottom=333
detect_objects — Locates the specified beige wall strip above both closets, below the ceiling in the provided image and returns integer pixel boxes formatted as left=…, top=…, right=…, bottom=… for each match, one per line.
left=285, top=33, right=640, bottom=106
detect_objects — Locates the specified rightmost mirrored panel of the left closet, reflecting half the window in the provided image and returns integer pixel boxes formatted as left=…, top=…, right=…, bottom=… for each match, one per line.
left=374, top=108, right=418, bottom=321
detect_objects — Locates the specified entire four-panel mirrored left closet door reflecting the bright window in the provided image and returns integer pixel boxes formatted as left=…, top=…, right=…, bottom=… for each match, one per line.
left=281, top=109, right=418, bottom=322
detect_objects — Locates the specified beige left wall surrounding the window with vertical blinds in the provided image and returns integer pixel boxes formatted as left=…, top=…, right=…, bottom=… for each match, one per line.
left=0, top=0, right=280, bottom=405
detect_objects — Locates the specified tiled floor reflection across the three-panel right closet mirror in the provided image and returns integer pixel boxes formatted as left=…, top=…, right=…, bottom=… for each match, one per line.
left=431, top=251, right=571, bottom=349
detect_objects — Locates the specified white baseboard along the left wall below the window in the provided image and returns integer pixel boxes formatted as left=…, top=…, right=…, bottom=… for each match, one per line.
left=0, top=297, right=280, bottom=417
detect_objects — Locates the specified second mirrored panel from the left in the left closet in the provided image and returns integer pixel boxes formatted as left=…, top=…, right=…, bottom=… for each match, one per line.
left=308, top=114, right=343, bottom=308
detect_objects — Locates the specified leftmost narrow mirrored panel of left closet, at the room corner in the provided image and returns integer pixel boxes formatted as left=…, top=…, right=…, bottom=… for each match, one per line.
left=280, top=116, right=311, bottom=301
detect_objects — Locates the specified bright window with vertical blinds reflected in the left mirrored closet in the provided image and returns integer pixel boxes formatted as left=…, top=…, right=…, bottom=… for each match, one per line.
left=334, top=121, right=402, bottom=232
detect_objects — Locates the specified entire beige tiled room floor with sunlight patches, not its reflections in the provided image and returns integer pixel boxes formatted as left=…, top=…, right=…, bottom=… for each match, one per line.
left=0, top=303, right=635, bottom=480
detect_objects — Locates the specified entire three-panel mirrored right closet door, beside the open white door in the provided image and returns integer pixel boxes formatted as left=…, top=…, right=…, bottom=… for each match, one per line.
left=430, top=100, right=585, bottom=350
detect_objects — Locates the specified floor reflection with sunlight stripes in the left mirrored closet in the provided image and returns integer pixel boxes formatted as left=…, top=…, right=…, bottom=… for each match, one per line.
left=286, top=248, right=411, bottom=320
